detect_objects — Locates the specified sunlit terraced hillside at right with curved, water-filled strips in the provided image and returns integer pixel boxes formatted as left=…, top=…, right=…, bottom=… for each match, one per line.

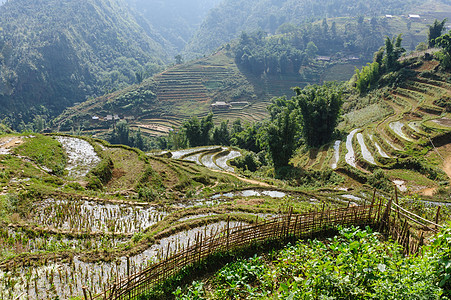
left=294, top=61, right=451, bottom=195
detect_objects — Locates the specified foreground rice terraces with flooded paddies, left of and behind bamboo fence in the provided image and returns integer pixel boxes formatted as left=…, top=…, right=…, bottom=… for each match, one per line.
left=0, top=134, right=384, bottom=300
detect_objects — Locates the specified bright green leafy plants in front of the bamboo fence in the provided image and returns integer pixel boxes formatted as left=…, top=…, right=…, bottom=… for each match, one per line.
left=177, top=227, right=451, bottom=300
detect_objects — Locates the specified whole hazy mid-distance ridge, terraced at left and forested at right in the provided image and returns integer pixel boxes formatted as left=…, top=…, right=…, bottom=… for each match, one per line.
left=55, top=17, right=438, bottom=141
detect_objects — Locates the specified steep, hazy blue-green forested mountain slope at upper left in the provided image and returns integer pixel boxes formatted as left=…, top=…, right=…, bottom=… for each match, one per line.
left=0, top=0, right=166, bottom=125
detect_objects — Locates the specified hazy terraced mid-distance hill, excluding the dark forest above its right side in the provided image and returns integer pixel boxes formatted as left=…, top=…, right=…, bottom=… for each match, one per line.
left=55, top=45, right=370, bottom=136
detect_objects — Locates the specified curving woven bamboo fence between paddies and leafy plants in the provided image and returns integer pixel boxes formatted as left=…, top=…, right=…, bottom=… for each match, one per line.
left=83, top=192, right=440, bottom=300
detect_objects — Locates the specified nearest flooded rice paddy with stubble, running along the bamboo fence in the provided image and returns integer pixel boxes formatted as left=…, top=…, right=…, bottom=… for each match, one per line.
left=0, top=222, right=242, bottom=300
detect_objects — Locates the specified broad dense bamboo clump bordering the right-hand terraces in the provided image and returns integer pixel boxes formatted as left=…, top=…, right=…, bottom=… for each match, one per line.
left=294, top=83, right=343, bottom=147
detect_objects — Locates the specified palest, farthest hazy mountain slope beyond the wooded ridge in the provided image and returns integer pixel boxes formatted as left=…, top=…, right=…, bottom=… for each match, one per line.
left=186, top=0, right=449, bottom=54
